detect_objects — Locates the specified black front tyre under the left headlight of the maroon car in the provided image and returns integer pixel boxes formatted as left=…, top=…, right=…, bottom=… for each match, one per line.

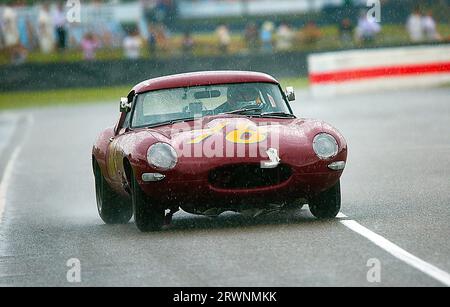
left=131, top=170, right=165, bottom=232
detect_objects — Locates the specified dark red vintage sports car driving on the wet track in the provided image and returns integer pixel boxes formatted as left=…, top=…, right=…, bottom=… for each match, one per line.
left=92, top=71, right=347, bottom=231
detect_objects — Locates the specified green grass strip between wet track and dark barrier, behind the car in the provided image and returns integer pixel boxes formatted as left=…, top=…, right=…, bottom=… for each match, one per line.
left=0, top=78, right=308, bottom=110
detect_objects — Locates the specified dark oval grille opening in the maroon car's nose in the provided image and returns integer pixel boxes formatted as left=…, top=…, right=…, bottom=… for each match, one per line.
left=209, top=164, right=292, bottom=189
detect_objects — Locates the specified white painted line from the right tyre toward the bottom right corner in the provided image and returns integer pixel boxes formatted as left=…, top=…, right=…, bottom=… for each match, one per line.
left=338, top=213, right=450, bottom=287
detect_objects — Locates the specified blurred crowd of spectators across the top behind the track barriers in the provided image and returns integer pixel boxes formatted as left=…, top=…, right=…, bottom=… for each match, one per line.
left=0, top=0, right=441, bottom=63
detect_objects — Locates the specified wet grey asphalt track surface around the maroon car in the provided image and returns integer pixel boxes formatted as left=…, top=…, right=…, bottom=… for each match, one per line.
left=0, top=88, right=450, bottom=286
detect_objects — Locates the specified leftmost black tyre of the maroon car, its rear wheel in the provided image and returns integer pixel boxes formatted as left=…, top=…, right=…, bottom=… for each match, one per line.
left=94, top=162, right=133, bottom=224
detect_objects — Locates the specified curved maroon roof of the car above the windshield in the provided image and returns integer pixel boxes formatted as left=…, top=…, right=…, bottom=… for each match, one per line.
left=133, top=71, right=279, bottom=94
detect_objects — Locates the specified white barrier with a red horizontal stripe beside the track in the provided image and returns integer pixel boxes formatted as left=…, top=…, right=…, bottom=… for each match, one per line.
left=308, top=45, right=450, bottom=96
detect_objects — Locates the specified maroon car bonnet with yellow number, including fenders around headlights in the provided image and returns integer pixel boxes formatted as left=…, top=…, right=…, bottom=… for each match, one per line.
left=123, top=116, right=347, bottom=174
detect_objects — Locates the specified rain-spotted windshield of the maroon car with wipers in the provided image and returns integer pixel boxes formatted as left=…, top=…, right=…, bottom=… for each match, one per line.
left=132, top=83, right=291, bottom=127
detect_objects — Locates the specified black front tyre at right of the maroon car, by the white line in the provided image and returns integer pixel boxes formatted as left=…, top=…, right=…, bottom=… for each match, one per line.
left=309, top=181, right=341, bottom=219
